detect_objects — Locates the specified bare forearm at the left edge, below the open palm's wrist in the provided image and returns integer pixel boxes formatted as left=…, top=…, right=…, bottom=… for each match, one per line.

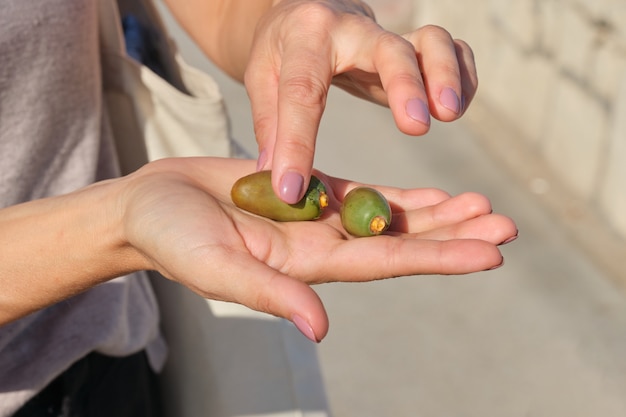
left=0, top=180, right=145, bottom=324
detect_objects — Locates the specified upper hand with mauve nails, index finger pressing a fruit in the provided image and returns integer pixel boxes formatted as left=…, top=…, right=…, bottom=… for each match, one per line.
left=245, top=0, right=478, bottom=202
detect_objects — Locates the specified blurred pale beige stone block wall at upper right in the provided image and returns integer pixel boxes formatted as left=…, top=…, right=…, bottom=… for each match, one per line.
left=370, top=0, right=626, bottom=254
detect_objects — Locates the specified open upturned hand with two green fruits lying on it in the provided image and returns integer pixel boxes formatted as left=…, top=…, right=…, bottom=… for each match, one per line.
left=123, top=158, right=517, bottom=341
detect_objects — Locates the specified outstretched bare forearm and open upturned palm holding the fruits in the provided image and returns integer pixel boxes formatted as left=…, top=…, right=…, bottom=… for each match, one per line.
left=0, top=158, right=517, bottom=341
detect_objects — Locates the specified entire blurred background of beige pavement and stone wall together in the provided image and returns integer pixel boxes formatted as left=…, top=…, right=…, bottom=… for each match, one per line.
left=155, top=0, right=626, bottom=417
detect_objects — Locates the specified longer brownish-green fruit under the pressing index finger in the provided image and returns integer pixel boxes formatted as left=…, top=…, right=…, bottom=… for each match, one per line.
left=230, top=171, right=328, bottom=222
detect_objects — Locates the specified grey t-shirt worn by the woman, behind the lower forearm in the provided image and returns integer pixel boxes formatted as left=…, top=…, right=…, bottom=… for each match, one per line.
left=0, top=0, right=166, bottom=416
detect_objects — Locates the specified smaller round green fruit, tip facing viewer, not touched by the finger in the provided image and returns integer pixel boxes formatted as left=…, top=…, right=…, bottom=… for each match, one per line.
left=341, top=187, right=391, bottom=236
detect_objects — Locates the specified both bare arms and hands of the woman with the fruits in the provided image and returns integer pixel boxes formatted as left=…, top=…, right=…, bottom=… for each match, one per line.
left=0, top=0, right=517, bottom=341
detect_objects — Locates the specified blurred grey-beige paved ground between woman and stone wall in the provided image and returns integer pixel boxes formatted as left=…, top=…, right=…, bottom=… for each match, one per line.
left=158, top=8, right=626, bottom=417
